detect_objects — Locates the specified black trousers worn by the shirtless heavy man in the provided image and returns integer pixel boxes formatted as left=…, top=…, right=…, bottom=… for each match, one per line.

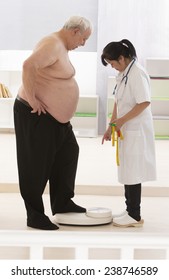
left=14, top=99, right=79, bottom=223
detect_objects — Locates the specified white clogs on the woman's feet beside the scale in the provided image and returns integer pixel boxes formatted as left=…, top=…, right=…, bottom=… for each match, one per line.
left=113, top=213, right=144, bottom=227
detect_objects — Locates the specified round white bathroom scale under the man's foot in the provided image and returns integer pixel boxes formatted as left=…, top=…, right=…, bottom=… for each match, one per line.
left=54, top=207, right=112, bottom=226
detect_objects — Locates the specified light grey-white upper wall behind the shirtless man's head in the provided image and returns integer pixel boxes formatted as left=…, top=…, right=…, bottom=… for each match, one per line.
left=0, top=0, right=98, bottom=51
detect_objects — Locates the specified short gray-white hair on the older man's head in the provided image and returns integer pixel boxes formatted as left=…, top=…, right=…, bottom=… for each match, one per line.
left=63, top=16, right=92, bottom=32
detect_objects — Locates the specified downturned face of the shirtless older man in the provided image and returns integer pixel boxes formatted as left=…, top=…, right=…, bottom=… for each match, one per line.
left=70, top=28, right=91, bottom=50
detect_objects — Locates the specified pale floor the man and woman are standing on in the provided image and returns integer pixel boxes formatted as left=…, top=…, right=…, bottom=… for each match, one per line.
left=0, top=193, right=169, bottom=234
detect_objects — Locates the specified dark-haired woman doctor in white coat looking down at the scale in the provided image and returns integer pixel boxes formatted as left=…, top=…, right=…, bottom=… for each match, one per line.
left=101, top=39, right=156, bottom=227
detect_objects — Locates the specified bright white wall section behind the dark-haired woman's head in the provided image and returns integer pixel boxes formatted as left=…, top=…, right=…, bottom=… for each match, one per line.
left=97, top=0, right=169, bottom=134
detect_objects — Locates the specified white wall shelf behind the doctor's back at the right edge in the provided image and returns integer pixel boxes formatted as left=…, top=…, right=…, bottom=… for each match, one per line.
left=146, top=58, right=169, bottom=139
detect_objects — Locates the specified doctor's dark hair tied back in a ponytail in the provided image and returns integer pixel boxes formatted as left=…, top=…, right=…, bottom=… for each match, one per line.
left=101, top=39, right=137, bottom=66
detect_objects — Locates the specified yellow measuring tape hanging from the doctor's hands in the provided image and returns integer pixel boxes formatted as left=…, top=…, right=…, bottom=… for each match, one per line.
left=109, top=123, right=123, bottom=166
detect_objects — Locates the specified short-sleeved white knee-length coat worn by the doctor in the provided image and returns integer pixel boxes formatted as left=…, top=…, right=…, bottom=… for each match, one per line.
left=115, top=62, right=156, bottom=185
